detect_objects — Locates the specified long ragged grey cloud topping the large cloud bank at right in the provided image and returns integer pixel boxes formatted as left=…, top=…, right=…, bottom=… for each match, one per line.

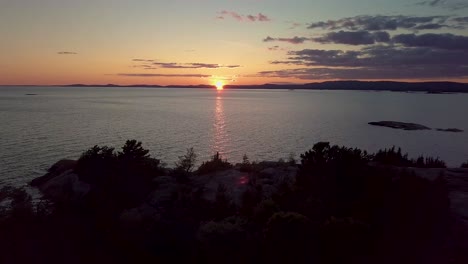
left=308, top=15, right=450, bottom=31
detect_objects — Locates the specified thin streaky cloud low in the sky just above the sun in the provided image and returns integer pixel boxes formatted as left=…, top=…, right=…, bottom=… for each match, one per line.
left=132, top=59, right=241, bottom=69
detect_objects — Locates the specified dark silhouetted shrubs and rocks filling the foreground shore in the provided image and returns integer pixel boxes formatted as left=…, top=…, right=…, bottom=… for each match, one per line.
left=0, top=140, right=467, bottom=264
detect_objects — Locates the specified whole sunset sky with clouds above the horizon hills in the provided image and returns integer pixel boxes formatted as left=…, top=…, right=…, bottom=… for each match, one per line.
left=0, top=0, right=468, bottom=85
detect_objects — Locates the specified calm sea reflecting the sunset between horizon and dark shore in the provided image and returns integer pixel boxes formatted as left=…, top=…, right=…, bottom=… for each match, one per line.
left=0, top=87, right=468, bottom=185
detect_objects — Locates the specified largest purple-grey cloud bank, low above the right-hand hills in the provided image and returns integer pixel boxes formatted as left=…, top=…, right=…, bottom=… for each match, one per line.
left=266, top=45, right=468, bottom=80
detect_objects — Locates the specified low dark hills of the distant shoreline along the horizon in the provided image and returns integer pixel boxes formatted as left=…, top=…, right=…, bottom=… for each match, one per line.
left=0, top=81, right=468, bottom=94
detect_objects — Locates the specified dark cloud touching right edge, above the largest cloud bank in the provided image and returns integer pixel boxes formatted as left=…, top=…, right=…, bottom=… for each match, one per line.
left=392, top=33, right=468, bottom=51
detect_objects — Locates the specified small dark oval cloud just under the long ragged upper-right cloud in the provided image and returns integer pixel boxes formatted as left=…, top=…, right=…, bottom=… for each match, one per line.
left=314, top=30, right=390, bottom=45
